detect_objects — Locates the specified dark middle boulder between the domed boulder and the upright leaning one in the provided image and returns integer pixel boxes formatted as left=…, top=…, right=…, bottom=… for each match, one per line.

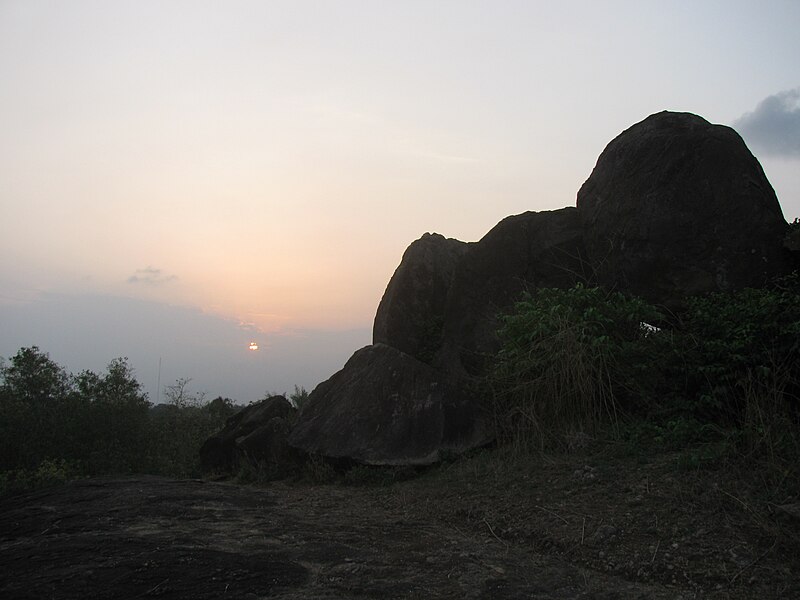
left=435, top=207, right=587, bottom=375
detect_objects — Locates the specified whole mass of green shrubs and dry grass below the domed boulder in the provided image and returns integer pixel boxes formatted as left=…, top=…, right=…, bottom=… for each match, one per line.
left=487, top=274, right=800, bottom=493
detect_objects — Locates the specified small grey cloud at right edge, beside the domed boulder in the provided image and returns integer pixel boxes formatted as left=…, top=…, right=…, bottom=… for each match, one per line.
left=733, top=88, right=800, bottom=157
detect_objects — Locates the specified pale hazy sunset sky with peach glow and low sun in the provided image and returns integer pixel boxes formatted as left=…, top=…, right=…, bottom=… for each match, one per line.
left=0, top=0, right=800, bottom=403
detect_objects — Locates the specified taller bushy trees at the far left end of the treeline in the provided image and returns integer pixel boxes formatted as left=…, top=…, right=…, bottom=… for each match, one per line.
left=0, top=346, right=150, bottom=473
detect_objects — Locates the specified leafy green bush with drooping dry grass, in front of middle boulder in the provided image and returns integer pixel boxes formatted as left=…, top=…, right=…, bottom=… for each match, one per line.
left=490, top=285, right=659, bottom=446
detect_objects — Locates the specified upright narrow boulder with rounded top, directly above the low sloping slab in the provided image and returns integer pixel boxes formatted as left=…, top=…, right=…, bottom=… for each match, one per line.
left=372, top=233, right=469, bottom=362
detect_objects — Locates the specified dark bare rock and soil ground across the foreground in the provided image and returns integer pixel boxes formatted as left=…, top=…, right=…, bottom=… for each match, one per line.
left=0, top=453, right=800, bottom=600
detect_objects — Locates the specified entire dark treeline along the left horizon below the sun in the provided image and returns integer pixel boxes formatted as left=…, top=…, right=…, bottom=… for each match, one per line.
left=0, top=346, right=237, bottom=491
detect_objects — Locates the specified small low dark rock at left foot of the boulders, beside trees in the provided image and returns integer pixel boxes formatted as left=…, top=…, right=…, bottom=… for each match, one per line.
left=200, top=396, right=296, bottom=472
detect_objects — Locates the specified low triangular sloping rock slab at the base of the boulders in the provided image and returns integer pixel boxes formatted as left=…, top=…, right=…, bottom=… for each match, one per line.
left=289, top=344, right=491, bottom=465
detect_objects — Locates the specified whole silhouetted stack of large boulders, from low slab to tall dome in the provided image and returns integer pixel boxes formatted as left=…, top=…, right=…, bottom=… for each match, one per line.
left=209, top=112, right=795, bottom=464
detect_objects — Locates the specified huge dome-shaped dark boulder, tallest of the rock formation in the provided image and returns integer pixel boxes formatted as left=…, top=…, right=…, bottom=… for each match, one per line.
left=577, top=112, right=790, bottom=306
